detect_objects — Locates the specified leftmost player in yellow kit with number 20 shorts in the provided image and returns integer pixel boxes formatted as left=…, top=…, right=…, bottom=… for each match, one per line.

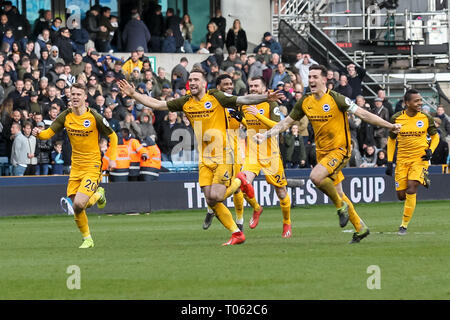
left=33, top=83, right=118, bottom=249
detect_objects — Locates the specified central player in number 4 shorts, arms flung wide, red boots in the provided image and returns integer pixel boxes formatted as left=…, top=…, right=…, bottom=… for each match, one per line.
left=119, top=69, right=281, bottom=245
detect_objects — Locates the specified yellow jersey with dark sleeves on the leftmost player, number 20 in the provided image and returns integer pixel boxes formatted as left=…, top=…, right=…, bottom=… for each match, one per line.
left=39, top=108, right=114, bottom=171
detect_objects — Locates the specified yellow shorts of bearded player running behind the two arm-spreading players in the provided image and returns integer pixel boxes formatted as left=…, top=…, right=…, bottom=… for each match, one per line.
left=242, top=156, right=287, bottom=188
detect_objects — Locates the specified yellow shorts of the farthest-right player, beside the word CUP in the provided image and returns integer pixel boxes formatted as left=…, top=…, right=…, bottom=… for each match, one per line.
left=395, top=160, right=430, bottom=190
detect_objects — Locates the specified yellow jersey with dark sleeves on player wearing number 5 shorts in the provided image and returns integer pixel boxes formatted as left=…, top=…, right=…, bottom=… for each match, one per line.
left=289, top=90, right=353, bottom=156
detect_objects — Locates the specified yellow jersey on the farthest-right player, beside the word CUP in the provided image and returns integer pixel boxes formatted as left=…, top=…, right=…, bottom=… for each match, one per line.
left=389, top=110, right=437, bottom=161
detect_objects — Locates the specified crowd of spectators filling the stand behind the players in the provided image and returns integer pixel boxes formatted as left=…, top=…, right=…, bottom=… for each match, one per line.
left=0, top=1, right=450, bottom=175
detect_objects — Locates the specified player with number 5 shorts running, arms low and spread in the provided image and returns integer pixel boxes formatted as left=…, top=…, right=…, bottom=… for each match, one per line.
left=254, top=65, right=401, bottom=243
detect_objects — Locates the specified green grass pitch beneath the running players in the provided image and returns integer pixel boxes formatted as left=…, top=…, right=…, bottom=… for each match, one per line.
left=0, top=201, right=450, bottom=300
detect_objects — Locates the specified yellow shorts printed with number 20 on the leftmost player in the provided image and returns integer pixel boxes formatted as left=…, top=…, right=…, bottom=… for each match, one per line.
left=67, top=169, right=102, bottom=198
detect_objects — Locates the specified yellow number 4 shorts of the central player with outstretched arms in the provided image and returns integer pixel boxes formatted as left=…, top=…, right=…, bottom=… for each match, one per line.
left=198, top=162, right=234, bottom=187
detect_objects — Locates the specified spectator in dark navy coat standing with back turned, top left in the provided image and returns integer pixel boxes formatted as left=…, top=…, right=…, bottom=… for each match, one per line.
left=122, top=13, right=151, bottom=52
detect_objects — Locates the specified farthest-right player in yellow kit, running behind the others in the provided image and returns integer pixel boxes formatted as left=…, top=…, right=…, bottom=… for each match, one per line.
left=386, top=89, right=439, bottom=235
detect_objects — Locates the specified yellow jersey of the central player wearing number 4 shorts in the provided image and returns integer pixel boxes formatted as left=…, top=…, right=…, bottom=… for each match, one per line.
left=167, top=89, right=237, bottom=164
